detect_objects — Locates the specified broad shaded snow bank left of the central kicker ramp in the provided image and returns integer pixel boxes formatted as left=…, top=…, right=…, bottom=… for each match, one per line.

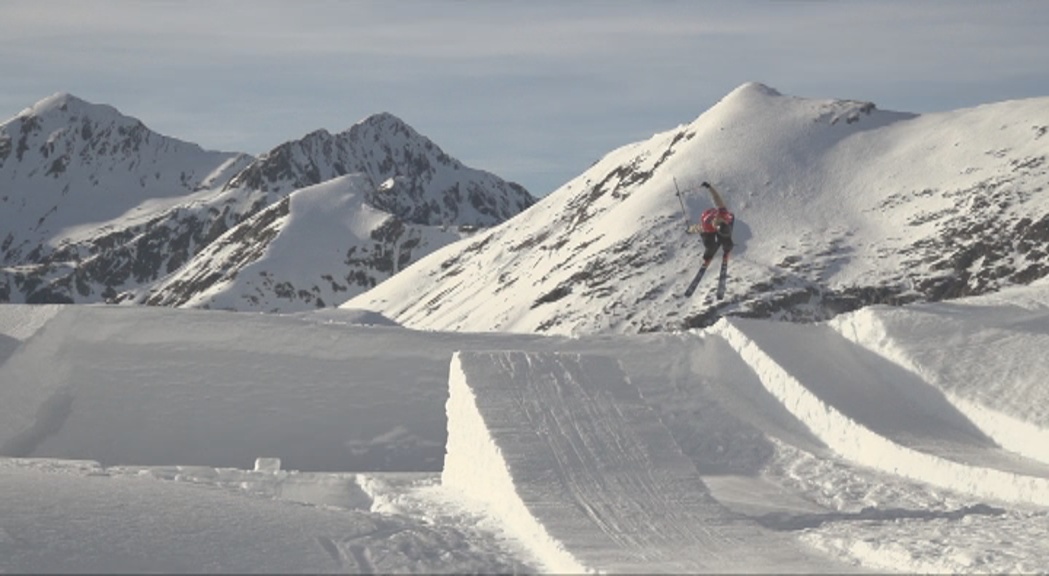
left=0, top=305, right=451, bottom=472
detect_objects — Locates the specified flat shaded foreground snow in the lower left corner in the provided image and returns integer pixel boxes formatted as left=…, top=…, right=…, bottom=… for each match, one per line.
left=0, top=458, right=527, bottom=574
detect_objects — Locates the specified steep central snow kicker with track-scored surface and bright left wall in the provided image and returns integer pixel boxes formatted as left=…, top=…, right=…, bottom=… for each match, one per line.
left=442, top=351, right=840, bottom=573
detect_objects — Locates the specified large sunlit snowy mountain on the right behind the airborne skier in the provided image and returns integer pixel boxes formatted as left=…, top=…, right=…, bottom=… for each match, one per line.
left=344, top=83, right=1049, bottom=334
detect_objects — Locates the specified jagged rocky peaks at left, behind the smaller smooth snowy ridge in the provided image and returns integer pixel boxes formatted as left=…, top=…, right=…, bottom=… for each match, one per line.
left=0, top=92, right=535, bottom=310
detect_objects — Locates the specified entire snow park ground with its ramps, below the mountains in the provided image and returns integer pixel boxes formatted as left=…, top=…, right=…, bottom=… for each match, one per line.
left=0, top=282, right=1049, bottom=573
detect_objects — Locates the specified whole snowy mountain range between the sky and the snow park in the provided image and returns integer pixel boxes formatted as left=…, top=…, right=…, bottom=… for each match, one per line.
left=0, top=82, right=1049, bottom=335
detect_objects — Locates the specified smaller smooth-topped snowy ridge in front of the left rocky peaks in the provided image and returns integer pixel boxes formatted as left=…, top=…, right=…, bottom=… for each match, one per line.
left=143, top=174, right=466, bottom=312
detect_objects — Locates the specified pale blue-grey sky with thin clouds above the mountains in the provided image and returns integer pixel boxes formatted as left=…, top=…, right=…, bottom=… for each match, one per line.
left=0, top=0, right=1049, bottom=196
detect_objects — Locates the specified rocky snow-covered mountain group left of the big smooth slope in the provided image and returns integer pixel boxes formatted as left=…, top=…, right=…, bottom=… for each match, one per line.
left=0, top=93, right=535, bottom=311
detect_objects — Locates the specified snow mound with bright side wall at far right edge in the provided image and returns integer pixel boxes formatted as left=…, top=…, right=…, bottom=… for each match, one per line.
left=831, top=285, right=1049, bottom=463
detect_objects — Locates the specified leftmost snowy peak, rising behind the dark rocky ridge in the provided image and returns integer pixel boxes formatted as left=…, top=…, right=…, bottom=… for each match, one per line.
left=0, top=93, right=248, bottom=254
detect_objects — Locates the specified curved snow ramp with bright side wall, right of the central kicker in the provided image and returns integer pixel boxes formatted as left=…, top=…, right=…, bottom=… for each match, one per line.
left=712, top=318, right=1049, bottom=506
